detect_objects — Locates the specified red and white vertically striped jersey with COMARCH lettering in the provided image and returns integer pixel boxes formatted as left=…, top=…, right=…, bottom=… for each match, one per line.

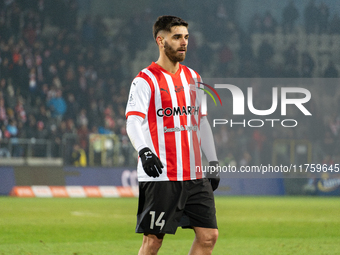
left=126, top=62, right=203, bottom=181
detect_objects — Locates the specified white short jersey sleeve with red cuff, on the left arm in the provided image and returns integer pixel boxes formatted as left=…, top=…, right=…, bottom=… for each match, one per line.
left=125, top=77, right=151, bottom=119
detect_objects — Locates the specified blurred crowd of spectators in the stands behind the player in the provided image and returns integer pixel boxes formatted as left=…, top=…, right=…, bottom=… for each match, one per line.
left=0, top=0, right=340, bottom=165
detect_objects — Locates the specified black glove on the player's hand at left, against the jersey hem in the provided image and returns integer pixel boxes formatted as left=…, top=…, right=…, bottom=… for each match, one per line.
left=138, top=147, right=164, bottom=178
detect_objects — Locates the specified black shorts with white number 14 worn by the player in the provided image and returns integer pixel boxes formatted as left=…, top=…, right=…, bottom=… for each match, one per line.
left=136, top=178, right=217, bottom=234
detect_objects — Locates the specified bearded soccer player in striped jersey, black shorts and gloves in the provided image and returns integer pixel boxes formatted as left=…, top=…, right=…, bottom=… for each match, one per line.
left=126, top=16, right=220, bottom=255
